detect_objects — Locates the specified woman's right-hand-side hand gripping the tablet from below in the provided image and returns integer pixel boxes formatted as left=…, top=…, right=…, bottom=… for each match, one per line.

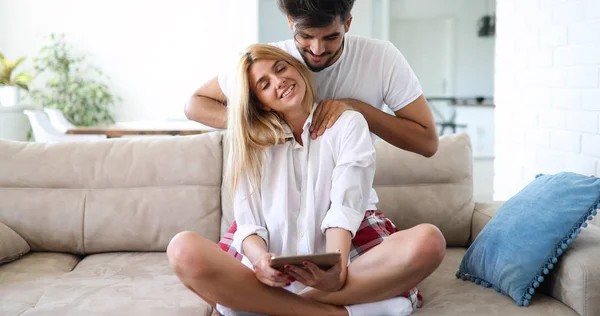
left=283, top=260, right=348, bottom=292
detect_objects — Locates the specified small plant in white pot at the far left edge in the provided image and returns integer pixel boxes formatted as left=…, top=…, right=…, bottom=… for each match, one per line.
left=0, top=53, right=33, bottom=106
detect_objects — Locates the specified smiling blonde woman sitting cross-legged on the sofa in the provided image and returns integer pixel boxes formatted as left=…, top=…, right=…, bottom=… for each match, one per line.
left=167, top=44, right=420, bottom=316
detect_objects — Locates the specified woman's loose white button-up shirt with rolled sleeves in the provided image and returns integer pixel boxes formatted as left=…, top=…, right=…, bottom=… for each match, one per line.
left=232, top=106, right=375, bottom=292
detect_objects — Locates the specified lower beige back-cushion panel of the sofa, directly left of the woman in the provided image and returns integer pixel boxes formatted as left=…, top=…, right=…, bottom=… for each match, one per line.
left=83, top=185, right=221, bottom=254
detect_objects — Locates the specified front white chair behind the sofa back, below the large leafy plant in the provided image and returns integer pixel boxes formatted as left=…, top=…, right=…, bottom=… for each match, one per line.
left=23, top=110, right=106, bottom=143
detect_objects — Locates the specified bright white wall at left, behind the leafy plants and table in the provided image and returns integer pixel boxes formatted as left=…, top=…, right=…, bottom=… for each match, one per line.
left=0, top=0, right=258, bottom=120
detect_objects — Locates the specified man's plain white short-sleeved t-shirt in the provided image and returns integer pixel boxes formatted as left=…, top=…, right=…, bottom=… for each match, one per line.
left=218, top=34, right=423, bottom=210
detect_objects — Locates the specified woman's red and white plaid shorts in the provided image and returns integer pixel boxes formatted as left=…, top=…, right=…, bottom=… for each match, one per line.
left=219, top=211, right=423, bottom=309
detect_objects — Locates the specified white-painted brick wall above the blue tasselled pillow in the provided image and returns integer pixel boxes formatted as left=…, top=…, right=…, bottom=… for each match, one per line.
left=494, top=0, right=600, bottom=200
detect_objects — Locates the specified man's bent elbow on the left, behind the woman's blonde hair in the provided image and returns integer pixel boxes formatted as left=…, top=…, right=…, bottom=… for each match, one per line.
left=184, top=77, right=227, bottom=129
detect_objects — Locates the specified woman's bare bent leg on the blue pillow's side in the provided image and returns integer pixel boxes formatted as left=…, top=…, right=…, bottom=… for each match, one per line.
left=302, top=224, right=446, bottom=305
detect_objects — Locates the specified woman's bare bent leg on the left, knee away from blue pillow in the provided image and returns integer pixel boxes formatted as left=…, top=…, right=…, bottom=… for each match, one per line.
left=167, top=232, right=348, bottom=316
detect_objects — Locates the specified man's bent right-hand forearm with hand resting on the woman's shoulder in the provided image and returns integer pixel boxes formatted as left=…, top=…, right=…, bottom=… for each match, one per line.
left=311, top=95, right=438, bottom=157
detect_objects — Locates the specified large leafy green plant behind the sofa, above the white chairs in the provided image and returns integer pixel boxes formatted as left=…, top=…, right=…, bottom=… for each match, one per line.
left=31, top=34, right=120, bottom=126
